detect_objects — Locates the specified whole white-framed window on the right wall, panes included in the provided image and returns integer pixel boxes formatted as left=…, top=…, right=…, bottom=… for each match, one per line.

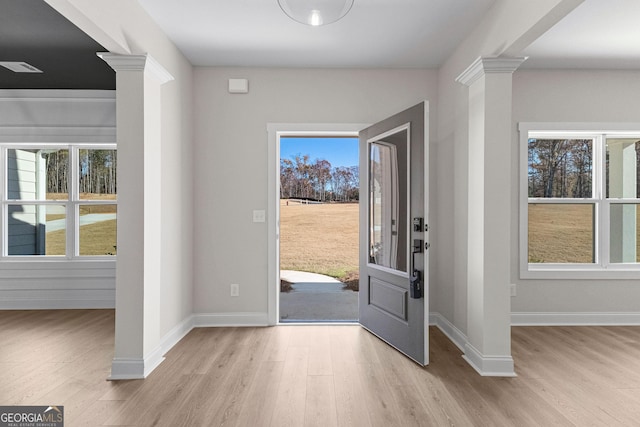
left=519, top=123, right=640, bottom=278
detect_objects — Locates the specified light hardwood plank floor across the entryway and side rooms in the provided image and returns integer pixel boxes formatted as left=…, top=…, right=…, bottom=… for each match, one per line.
left=0, top=310, right=640, bottom=427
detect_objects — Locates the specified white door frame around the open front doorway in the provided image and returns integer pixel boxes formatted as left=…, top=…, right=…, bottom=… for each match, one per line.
left=267, top=123, right=369, bottom=326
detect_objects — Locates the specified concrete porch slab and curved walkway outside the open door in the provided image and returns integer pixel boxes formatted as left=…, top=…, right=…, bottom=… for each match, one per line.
left=280, top=270, right=358, bottom=322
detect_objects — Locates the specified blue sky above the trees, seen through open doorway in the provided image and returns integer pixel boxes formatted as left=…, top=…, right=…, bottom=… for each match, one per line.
left=280, top=137, right=358, bottom=168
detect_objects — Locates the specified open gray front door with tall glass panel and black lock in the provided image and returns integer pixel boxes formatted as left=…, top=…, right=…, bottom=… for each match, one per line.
left=359, top=102, right=429, bottom=365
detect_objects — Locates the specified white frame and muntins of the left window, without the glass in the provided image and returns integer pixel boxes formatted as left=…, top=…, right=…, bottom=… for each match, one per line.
left=0, top=142, right=118, bottom=262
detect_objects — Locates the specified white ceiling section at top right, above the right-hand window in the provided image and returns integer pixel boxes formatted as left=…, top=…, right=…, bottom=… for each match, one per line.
left=523, top=0, right=640, bottom=69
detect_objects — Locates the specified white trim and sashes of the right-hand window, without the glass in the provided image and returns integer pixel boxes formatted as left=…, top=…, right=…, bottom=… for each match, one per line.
left=518, top=122, right=640, bottom=280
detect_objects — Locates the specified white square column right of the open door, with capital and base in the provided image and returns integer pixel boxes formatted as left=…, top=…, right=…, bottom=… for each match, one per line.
left=456, top=58, right=525, bottom=376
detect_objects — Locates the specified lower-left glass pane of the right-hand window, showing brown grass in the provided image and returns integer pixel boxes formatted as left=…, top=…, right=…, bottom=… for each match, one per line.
left=529, top=203, right=595, bottom=263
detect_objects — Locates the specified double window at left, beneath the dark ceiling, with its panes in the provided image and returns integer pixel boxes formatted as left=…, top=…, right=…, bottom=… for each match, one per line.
left=0, top=143, right=117, bottom=259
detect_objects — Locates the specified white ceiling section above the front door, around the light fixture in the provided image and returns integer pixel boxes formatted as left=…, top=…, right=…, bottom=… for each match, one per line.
left=139, top=0, right=496, bottom=68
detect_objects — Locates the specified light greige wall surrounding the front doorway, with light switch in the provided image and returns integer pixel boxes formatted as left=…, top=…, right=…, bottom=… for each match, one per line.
left=194, top=68, right=437, bottom=317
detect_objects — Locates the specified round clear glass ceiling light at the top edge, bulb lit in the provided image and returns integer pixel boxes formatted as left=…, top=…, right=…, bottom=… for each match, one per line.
left=278, top=0, right=354, bottom=27
